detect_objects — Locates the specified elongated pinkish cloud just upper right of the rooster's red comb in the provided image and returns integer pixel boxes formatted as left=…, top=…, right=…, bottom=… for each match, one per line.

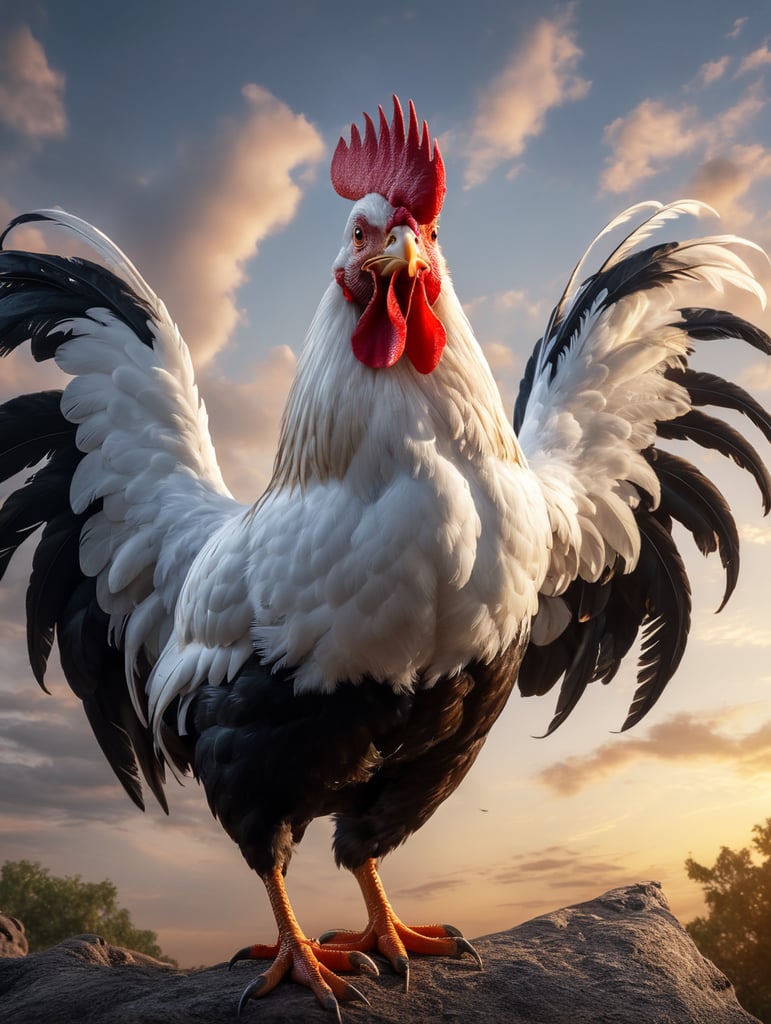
left=465, top=7, right=591, bottom=187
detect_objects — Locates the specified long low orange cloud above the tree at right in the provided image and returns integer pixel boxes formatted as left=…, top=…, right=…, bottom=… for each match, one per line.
left=537, top=713, right=771, bottom=797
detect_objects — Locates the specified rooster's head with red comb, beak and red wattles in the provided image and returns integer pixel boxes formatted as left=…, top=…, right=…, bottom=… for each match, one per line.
left=332, top=96, right=446, bottom=374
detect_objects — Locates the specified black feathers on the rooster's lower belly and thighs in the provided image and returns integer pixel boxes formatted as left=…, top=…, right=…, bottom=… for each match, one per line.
left=188, top=644, right=521, bottom=873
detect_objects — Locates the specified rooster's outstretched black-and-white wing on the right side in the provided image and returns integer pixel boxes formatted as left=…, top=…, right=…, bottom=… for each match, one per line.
left=514, top=201, right=771, bottom=732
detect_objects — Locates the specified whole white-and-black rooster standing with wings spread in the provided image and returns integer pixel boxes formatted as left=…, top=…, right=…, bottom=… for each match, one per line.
left=0, top=98, right=771, bottom=1017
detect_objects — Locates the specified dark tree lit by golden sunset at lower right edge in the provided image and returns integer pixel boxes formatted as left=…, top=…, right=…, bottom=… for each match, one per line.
left=685, top=818, right=771, bottom=1024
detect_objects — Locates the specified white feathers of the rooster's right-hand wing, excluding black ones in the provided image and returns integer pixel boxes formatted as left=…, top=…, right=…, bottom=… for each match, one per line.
left=518, top=209, right=765, bottom=606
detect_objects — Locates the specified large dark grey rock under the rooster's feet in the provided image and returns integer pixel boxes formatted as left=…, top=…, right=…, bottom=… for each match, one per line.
left=0, top=883, right=757, bottom=1024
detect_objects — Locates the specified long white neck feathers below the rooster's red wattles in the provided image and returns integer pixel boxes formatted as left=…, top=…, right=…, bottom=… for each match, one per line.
left=267, top=270, right=524, bottom=494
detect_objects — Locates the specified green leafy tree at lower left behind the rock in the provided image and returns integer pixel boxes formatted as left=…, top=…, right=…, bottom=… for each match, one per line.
left=0, top=860, right=176, bottom=966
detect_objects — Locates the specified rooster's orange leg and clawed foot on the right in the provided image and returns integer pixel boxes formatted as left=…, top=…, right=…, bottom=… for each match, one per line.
left=318, top=859, right=482, bottom=988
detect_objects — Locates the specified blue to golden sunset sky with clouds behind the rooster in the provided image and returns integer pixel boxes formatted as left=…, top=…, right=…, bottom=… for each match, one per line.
left=0, top=0, right=771, bottom=966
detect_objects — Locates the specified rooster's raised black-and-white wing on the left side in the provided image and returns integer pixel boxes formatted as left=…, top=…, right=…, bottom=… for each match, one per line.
left=0, top=211, right=244, bottom=806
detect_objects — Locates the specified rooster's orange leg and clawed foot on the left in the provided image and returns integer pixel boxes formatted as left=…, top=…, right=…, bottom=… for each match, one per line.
left=230, top=868, right=379, bottom=1021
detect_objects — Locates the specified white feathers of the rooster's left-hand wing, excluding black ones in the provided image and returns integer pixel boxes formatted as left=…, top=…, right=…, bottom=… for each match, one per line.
left=27, top=218, right=249, bottom=721
